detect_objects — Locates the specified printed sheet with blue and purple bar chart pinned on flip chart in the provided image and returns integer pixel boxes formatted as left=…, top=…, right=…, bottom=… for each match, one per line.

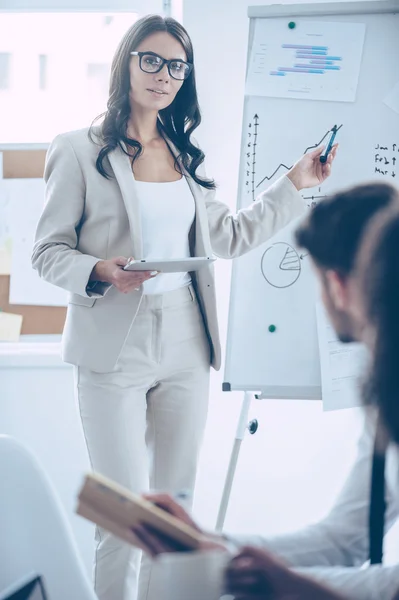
left=246, top=19, right=366, bottom=102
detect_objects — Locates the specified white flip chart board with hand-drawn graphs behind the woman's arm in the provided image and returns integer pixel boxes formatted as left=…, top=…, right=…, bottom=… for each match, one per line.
left=223, top=0, right=399, bottom=399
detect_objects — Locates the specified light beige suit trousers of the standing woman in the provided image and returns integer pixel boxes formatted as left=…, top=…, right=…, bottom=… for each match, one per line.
left=75, top=285, right=210, bottom=600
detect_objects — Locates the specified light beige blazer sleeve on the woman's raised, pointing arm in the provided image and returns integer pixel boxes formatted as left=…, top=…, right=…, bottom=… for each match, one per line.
left=205, top=175, right=306, bottom=258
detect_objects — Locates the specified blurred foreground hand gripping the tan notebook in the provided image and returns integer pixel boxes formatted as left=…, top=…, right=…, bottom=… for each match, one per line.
left=132, top=494, right=226, bottom=557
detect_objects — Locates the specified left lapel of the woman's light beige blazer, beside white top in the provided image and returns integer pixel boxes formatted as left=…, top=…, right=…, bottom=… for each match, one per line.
left=108, top=146, right=143, bottom=259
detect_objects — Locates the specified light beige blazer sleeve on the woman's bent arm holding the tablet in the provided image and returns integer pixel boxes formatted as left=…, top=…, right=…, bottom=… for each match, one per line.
left=32, top=135, right=109, bottom=297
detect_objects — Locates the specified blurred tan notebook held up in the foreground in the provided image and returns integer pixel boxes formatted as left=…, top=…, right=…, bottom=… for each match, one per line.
left=76, top=473, right=203, bottom=550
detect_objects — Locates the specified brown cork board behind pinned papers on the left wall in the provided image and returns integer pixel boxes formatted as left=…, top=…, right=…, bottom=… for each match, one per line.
left=0, top=148, right=66, bottom=334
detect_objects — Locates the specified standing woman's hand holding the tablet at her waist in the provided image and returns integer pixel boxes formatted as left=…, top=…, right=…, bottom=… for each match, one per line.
left=90, top=256, right=157, bottom=294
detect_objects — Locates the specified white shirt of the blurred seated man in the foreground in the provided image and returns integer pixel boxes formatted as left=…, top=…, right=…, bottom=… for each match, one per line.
left=229, top=408, right=399, bottom=600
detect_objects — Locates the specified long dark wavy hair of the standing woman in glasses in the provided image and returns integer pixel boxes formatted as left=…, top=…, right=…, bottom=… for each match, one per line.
left=89, top=15, right=216, bottom=189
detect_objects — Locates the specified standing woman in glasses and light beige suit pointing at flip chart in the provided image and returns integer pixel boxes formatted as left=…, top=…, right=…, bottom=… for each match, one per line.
left=32, top=16, right=336, bottom=600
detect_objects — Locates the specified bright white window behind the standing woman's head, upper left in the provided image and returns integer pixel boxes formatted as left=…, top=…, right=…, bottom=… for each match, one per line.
left=0, top=12, right=137, bottom=143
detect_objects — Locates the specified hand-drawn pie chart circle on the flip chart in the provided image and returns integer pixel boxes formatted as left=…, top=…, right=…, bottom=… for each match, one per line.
left=261, top=242, right=302, bottom=288
